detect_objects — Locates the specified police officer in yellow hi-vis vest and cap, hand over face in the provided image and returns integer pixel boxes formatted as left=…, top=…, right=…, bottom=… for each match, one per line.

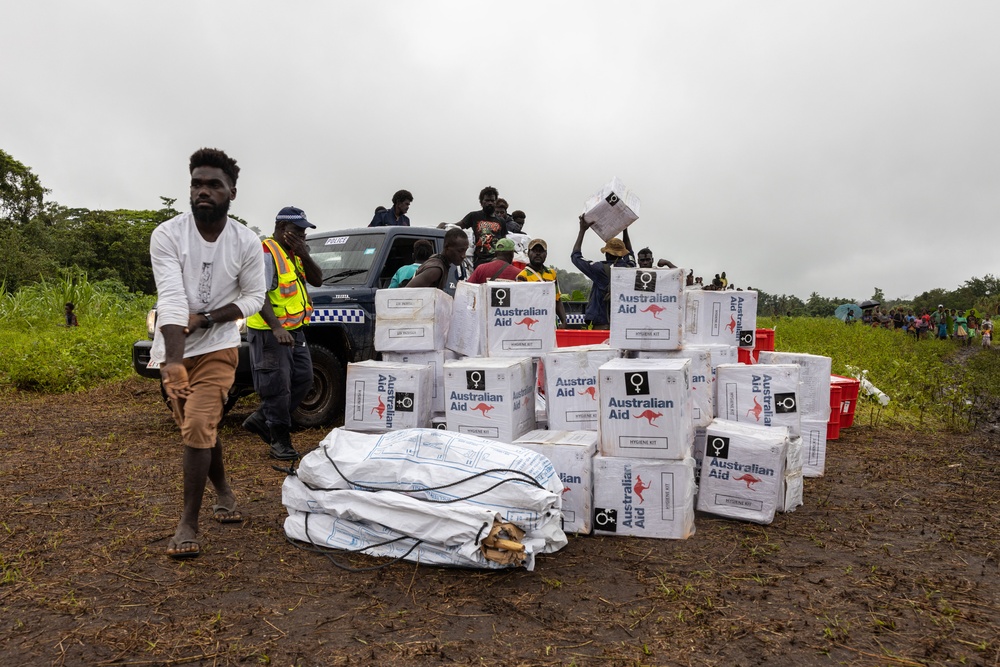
left=243, top=206, right=323, bottom=460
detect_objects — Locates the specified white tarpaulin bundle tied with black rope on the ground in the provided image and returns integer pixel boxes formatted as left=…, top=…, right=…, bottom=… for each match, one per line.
left=282, top=429, right=567, bottom=570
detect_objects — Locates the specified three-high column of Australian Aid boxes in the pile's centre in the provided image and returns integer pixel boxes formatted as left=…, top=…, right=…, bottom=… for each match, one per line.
left=594, top=268, right=695, bottom=539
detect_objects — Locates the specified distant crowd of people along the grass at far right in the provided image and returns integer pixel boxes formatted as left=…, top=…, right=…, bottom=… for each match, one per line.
left=845, top=305, right=993, bottom=347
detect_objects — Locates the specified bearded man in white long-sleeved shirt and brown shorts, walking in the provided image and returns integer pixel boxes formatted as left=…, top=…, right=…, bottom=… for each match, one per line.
left=149, top=148, right=264, bottom=558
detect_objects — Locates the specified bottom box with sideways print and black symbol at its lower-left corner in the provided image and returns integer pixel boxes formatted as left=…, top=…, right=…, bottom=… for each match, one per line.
left=594, top=456, right=695, bottom=540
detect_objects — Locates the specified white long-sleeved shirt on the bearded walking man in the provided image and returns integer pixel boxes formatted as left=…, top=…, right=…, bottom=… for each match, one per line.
left=149, top=213, right=265, bottom=363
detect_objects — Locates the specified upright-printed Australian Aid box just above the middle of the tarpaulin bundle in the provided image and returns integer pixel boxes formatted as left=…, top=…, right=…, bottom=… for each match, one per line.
left=444, top=357, right=535, bottom=443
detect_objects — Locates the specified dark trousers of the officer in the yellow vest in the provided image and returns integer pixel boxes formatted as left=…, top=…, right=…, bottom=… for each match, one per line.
left=247, top=329, right=312, bottom=426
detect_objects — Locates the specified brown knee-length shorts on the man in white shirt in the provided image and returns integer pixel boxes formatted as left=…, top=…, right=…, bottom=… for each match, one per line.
left=171, top=347, right=240, bottom=449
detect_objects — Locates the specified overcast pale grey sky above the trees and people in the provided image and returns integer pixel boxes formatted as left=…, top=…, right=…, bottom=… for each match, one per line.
left=0, top=0, right=1000, bottom=300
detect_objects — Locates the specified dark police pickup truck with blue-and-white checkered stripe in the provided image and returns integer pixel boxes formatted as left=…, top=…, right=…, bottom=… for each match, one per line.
left=132, top=227, right=444, bottom=428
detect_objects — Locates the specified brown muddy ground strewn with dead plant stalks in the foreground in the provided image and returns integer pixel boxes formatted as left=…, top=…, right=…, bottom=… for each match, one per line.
left=0, top=379, right=1000, bottom=667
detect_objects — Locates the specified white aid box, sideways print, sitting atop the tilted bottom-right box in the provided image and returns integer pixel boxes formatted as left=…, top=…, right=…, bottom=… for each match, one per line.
left=715, top=364, right=801, bottom=436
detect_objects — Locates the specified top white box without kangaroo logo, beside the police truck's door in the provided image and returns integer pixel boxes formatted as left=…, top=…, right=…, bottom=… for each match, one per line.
left=375, top=287, right=452, bottom=352
